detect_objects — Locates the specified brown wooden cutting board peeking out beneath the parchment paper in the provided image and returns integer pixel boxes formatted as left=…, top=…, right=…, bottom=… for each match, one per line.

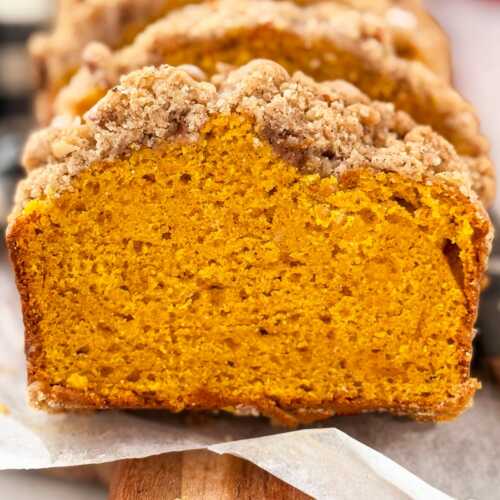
left=106, top=451, right=311, bottom=500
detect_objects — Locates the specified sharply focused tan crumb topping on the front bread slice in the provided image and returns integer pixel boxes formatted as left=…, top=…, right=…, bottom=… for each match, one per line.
left=12, top=60, right=476, bottom=225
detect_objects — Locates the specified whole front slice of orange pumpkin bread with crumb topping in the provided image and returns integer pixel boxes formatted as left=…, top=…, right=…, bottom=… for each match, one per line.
left=8, top=61, right=490, bottom=425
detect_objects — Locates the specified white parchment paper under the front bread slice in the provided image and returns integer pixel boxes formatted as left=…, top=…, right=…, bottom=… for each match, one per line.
left=0, top=261, right=500, bottom=500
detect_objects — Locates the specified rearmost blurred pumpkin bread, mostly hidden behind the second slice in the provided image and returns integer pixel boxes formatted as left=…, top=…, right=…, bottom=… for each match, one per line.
left=29, top=0, right=451, bottom=124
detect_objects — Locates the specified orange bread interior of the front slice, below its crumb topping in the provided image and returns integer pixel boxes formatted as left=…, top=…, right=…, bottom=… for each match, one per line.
left=9, top=114, right=487, bottom=424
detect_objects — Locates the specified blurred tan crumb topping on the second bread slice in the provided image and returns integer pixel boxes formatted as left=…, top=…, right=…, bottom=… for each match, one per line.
left=55, top=0, right=394, bottom=114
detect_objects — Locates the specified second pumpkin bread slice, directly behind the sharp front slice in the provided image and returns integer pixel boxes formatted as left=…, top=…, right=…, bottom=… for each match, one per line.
left=46, top=0, right=495, bottom=204
